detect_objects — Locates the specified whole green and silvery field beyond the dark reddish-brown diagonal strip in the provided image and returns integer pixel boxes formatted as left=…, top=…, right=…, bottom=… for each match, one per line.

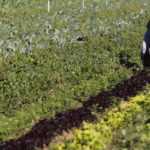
left=0, top=0, right=150, bottom=150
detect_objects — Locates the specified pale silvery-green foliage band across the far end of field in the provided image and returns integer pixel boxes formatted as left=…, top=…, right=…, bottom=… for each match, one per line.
left=0, top=0, right=148, bottom=57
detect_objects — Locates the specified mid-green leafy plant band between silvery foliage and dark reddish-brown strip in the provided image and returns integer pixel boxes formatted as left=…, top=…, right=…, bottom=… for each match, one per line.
left=0, top=34, right=131, bottom=139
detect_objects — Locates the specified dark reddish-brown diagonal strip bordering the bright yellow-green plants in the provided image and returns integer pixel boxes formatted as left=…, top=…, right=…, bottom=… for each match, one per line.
left=0, top=71, right=150, bottom=150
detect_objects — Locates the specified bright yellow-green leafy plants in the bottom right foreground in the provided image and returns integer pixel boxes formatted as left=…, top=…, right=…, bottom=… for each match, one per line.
left=49, top=90, right=150, bottom=150
